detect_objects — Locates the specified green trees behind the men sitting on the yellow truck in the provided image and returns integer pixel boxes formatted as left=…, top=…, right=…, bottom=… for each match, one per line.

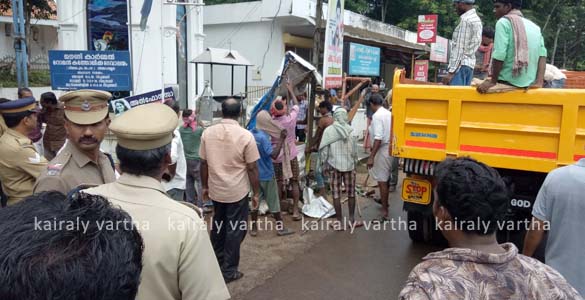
left=368, top=0, right=585, bottom=70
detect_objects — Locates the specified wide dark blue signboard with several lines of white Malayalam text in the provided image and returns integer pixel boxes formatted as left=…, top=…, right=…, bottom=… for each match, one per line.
left=49, top=50, right=132, bottom=91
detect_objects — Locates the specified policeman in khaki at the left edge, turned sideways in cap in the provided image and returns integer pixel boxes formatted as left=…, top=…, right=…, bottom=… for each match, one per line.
left=0, top=97, right=47, bottom=205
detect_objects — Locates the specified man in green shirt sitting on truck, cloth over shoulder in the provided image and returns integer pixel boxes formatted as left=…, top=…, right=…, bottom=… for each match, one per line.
left=477, top=0, right=546, bottom=93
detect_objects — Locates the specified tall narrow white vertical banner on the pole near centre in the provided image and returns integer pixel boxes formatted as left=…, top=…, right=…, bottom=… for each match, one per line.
left=323, top=0, right=344, bottom=89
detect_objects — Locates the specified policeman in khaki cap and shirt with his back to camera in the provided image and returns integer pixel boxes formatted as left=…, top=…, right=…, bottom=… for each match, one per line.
left=84, top=103, right=230, bottom=300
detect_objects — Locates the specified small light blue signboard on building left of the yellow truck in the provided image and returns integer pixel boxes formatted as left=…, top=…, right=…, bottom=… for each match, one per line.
left=349, top=43, right=380, bottom=76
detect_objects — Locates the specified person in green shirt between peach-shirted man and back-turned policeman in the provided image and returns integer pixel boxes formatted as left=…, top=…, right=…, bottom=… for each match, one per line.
left=179, top=109, right=212, bottom=212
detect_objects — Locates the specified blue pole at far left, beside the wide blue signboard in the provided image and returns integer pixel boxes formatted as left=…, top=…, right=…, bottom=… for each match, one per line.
left=12, top=0, right=28, bottom=88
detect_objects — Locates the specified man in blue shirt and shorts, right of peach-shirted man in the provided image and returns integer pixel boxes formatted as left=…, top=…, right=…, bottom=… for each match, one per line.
left=250, top=128, right=294, bottom=236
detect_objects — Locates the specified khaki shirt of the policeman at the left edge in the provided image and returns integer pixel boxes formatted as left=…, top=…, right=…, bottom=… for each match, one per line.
left=0, top=129, right=47, bottom=205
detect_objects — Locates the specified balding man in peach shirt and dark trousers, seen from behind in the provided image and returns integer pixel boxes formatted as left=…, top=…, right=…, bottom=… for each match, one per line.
left=199, top=98, right=260, bottom=283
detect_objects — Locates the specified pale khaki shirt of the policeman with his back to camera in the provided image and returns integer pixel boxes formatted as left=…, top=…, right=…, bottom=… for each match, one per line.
left=85, top=174, right=230, bottom=300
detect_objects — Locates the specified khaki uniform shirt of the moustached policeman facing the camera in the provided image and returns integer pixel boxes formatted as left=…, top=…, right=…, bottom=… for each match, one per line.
left=34, top=142, right=116, bottom=194
